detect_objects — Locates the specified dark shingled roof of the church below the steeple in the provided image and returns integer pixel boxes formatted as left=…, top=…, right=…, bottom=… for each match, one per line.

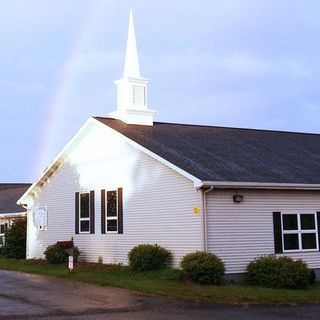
left=95, top=117, right=320, bottom=184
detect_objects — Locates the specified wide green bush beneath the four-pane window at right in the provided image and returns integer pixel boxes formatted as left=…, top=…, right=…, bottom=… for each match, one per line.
left=247, top=256, right=313, bottom=289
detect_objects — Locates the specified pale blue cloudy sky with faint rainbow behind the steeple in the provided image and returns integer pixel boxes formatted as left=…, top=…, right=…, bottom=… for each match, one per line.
left=0, top=0, right=320, bottom=182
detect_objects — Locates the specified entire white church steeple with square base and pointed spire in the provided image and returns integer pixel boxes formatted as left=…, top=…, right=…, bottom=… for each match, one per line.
left=110, top=10, right=155, bottom=126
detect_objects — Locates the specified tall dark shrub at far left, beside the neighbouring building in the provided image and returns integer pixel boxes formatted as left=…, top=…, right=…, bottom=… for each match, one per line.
left=1, top=218, right=27, bottom=259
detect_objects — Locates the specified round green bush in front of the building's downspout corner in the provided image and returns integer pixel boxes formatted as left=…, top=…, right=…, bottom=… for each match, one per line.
left=181, top=252, right=224, bottom=284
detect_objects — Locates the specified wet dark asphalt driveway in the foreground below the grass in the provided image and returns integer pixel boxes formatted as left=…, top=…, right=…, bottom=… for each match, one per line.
left=0, top=271, right=320, bottom=320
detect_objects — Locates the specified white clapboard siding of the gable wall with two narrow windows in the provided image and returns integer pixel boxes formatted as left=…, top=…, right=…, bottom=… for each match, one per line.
left=27, top=126, right=202, bottom=266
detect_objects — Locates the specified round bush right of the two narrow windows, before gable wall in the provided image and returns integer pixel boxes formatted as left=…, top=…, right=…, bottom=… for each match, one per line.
left=128, top=244, right=171, bottom=272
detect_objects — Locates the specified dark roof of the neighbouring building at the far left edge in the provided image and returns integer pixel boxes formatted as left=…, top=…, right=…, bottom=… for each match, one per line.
left=0, top=183, right=31, bottom=214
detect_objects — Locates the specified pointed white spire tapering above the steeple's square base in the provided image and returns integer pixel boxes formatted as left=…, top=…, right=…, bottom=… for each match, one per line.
left=123, top=9, right=141, bottom=78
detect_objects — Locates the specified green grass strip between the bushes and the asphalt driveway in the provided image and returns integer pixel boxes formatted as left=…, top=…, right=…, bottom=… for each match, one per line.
left=0, top=258, right=320, bottom=304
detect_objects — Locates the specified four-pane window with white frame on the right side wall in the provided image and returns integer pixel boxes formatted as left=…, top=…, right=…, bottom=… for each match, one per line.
left=282, top=213, right=319, bottom=252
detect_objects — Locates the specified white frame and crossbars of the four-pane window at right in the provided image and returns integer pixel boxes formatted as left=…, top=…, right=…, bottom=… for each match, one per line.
left=281, top=212, right=319, bottom=253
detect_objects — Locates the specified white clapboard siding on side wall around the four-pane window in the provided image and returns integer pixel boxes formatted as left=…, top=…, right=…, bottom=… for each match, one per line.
left=207, top=190, right=320, bottom=273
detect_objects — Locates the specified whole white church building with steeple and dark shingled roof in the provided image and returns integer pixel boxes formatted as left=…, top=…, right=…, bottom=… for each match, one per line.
left=18, top=13, right=320, bottom=275
